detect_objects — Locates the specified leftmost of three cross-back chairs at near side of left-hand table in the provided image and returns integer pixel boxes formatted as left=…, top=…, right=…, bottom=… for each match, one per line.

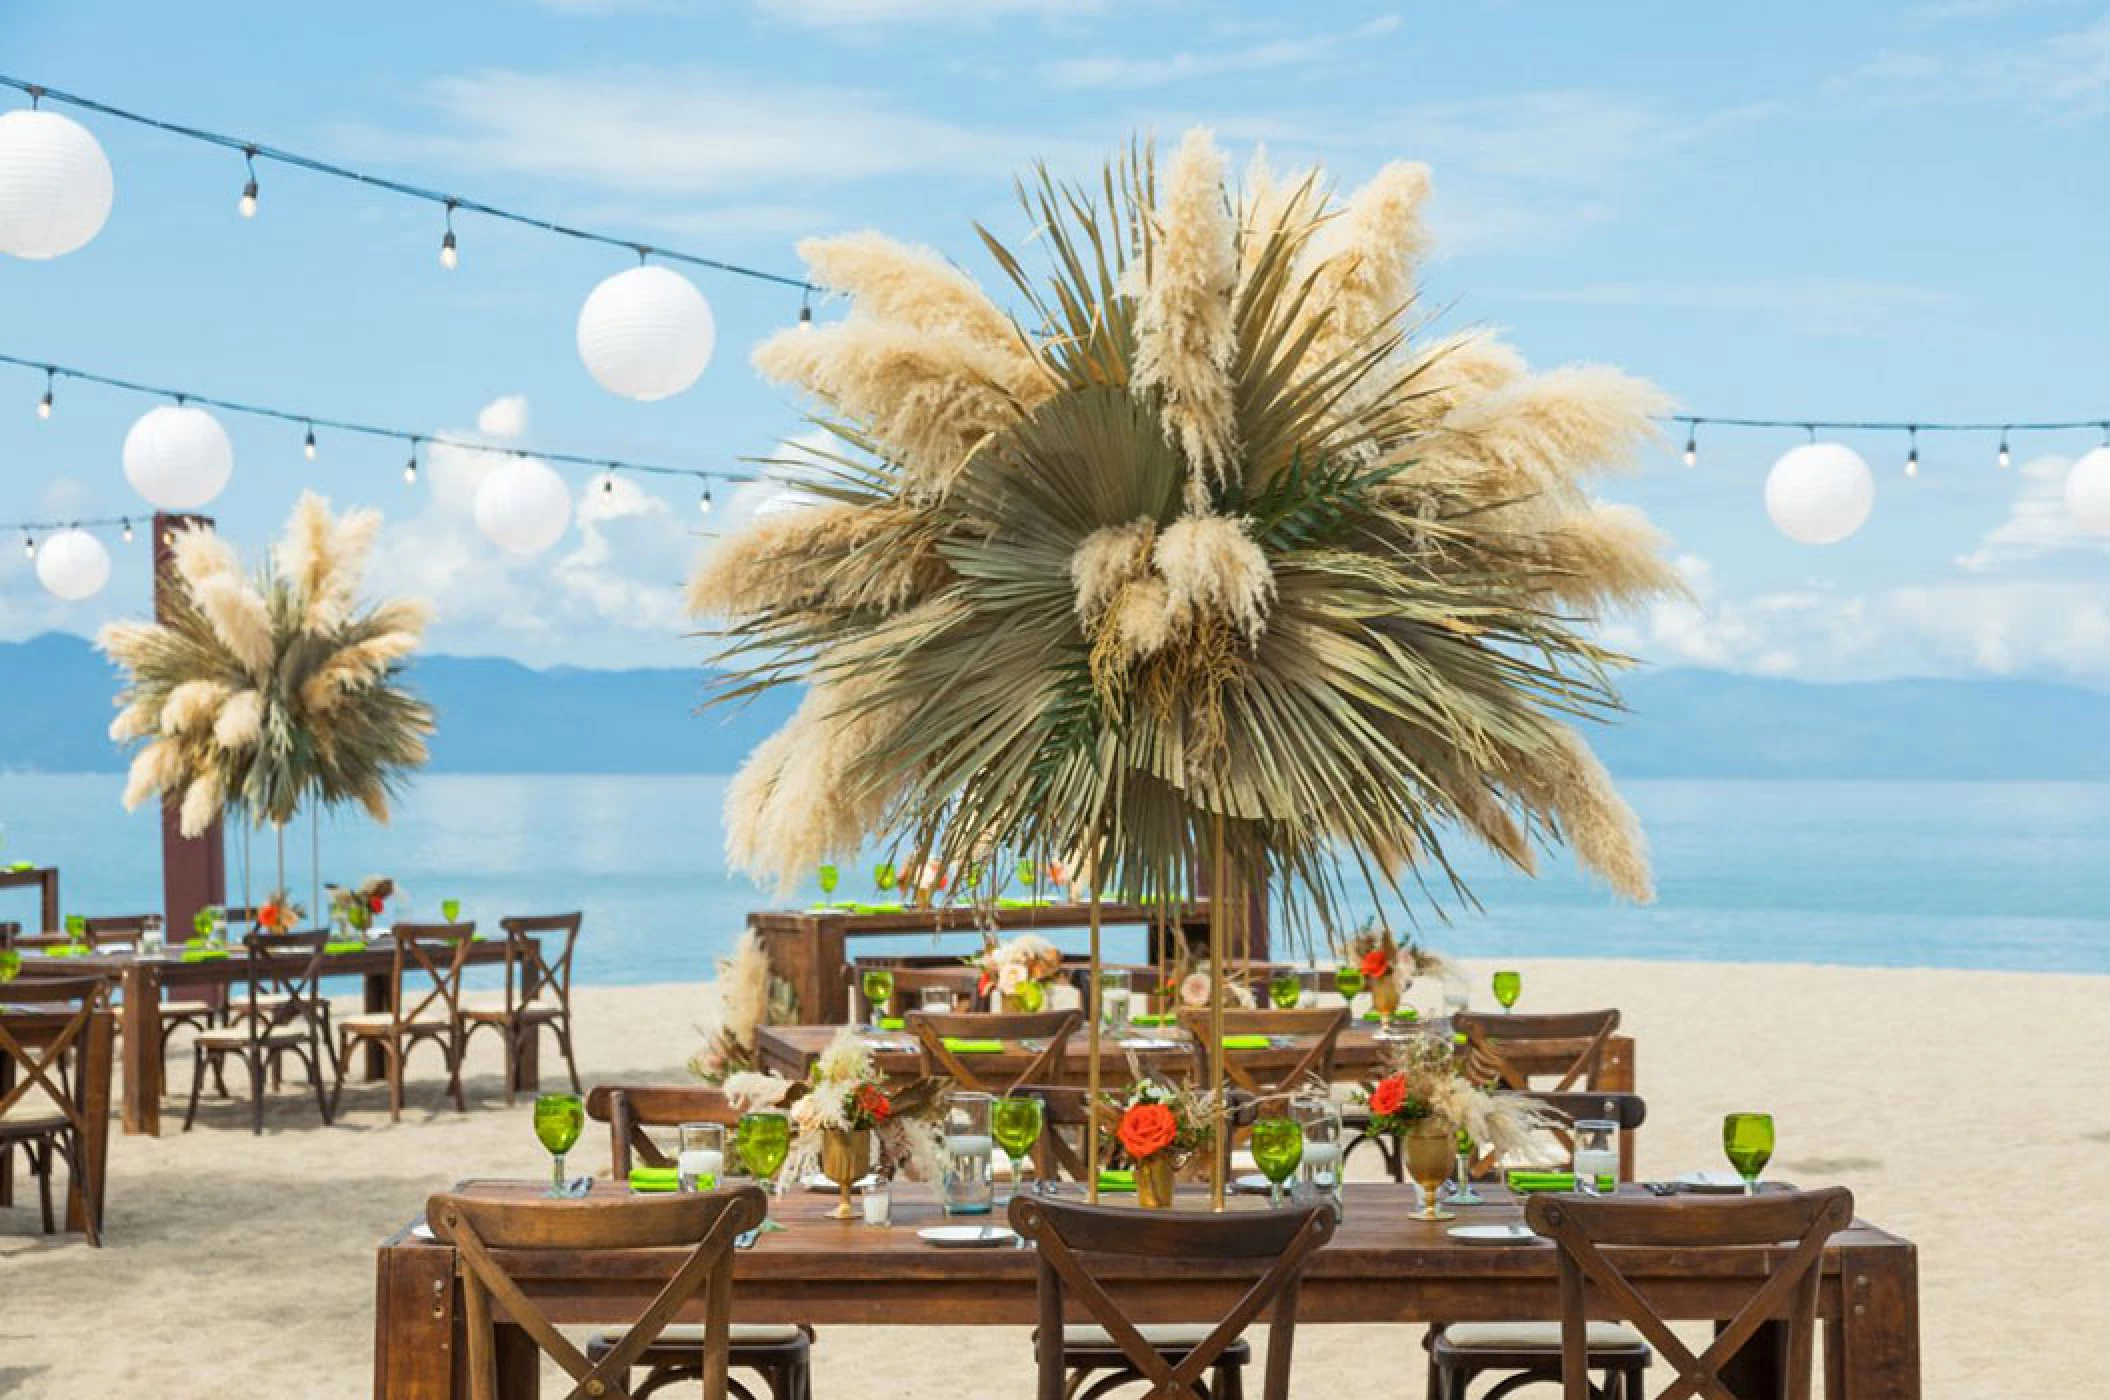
left=184, top=930, right=329, bottom=1134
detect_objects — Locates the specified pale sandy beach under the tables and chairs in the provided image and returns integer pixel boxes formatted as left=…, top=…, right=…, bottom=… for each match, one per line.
left=0, top=961, right=2110, bottom=1400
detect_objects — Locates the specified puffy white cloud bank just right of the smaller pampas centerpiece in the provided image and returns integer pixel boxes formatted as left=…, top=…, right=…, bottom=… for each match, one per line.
left=371, top=401, right=701, bottom=666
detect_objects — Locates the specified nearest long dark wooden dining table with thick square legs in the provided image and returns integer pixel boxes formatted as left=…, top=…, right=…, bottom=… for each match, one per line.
left=373, top=1181, right=1920, bottom=1400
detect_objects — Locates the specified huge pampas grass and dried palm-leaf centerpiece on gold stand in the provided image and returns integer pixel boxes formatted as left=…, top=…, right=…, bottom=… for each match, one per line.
left=690, top=131, right=1677, bottom=1200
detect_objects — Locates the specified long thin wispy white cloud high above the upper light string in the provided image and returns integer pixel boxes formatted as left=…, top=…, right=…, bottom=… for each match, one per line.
left=335, top=67, right=1080, bottom=198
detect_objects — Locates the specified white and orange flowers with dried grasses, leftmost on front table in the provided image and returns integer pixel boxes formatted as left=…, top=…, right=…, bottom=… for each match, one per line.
left=724, top=1027, right=945, bottom=1181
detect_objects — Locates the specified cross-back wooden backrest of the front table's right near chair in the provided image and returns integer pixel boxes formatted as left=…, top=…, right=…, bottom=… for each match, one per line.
left=1523, top=1187, right=1853, bottom=1400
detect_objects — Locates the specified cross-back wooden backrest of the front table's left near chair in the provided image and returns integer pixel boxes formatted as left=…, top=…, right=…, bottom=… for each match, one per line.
left=424, top=1185, right=764, bottom=1400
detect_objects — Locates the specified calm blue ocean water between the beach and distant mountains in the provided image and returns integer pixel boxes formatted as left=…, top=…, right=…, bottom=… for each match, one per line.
left=0, top=774, right=2110, bottom=983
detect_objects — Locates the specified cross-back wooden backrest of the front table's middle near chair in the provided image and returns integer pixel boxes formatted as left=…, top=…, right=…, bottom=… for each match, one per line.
left=1011, top=1195, right=1336, bottom=1400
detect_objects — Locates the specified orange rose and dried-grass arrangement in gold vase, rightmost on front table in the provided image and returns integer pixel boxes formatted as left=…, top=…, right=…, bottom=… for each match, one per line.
left=1365, top=1035, right=1553, bottom=1221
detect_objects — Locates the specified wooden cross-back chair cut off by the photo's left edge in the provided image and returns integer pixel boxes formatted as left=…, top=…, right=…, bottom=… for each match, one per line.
left=0, top=976, right=108, bottom=1244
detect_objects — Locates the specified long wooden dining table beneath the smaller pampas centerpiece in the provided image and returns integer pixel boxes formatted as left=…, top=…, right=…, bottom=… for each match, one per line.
left=21, top=938, right=540, bottom=1136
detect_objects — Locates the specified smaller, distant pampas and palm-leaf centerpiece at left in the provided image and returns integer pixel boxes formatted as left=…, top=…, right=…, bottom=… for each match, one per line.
left=99, top=493, right=433, bottom=890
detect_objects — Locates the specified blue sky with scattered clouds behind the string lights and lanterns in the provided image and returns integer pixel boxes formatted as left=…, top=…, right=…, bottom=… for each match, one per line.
left=0, top=0, right=2110, bottom=687
